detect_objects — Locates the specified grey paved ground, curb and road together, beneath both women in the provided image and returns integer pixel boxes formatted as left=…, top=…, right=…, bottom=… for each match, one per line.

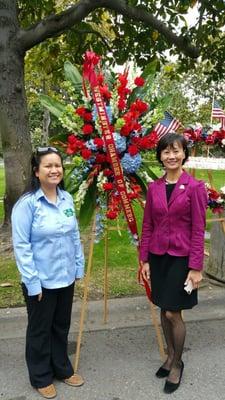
left=0, top=283, right=225, bottom=400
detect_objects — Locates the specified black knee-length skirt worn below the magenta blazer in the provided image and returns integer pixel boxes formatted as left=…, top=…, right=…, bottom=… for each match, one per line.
left=149, top=253, right=198, bottom=311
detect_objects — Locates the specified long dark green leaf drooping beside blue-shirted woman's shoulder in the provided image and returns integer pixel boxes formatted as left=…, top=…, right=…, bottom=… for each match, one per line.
left=79, top=180, right=97, bottom=228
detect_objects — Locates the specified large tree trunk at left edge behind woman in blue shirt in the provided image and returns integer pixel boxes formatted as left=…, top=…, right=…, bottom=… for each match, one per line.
left=0, top=0, right=31, bottom=224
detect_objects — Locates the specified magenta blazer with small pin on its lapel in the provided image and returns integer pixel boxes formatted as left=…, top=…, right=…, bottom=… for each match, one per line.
left=140, top=171, right=208, bottom=270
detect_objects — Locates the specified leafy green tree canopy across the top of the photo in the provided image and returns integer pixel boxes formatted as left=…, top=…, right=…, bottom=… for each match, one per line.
left=18, top=0, right=225, bottom=87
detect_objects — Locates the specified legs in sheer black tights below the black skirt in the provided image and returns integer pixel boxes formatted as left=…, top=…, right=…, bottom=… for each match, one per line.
left=161, top=310, right=186, bottom=383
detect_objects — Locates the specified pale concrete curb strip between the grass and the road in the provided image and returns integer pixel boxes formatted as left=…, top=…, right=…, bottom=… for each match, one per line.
left=0, top=282, right=225, bottom=340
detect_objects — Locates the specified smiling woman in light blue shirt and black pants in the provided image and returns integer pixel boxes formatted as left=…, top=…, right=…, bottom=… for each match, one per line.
left=12, top=147, right=84, bottom=398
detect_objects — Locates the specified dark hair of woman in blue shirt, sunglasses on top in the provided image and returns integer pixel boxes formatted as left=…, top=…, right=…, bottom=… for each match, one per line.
left=24, top=146, right=65, bottom=193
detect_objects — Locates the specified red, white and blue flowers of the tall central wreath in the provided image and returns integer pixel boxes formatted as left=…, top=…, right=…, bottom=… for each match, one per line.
left=62, top=61, right=158, bottom=219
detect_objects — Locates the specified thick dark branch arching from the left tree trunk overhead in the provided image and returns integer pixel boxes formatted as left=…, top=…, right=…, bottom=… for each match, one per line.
left=19, top=0, right=200, bottom=58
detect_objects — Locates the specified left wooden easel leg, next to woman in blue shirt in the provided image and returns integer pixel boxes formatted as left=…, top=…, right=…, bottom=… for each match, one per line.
left=74, top=214, right=96, bottom=372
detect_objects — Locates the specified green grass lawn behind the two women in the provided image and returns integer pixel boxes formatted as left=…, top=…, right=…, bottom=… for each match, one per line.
left=0, top=164, right=225, bottom=307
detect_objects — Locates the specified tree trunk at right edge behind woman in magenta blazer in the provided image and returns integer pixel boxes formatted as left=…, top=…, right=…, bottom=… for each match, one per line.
left=206, top=216, right=225, bottom=282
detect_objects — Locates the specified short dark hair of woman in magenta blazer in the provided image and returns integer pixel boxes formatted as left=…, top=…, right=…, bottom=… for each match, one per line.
left=156, top=132, right=189, bottom=164
